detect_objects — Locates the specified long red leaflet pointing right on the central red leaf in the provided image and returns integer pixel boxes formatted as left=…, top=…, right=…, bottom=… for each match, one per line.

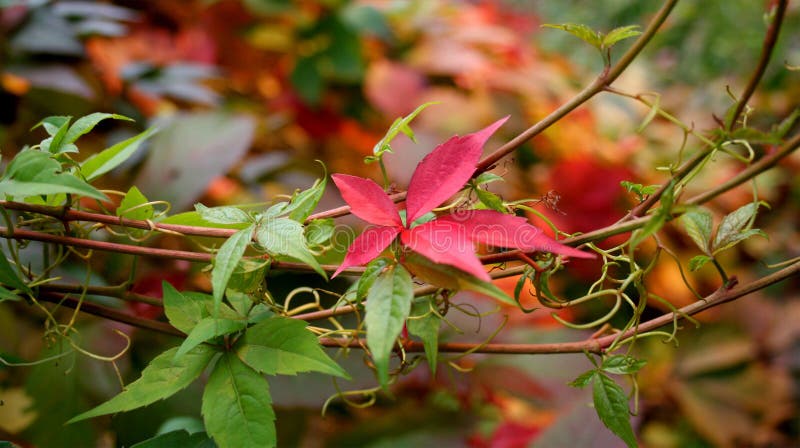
left=437, top=210, right=594, bottom=258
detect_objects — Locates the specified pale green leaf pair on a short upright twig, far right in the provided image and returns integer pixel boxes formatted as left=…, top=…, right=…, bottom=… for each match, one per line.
left=681, top=202, right=767, bottom=271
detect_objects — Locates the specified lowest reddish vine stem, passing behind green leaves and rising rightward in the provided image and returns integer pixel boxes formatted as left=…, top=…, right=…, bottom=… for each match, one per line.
left=40, top=261, right=800, bottom=355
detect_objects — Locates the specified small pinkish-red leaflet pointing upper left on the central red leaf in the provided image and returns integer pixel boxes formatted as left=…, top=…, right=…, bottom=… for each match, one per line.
left=331, top=174, right=402, bottom=226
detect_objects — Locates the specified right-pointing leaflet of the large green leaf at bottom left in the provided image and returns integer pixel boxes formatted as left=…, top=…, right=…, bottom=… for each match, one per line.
left=236, top=316, right=350, bottom=379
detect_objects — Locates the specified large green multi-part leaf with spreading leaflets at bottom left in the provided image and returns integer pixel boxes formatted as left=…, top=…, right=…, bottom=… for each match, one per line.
left=69, top=282, right=349, bottom=448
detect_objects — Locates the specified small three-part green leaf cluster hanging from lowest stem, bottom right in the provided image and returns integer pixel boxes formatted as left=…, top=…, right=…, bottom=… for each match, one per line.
left=570, top=355, right=647, bottom=448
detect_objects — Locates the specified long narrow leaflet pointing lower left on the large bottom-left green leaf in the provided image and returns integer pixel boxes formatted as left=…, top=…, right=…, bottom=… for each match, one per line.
left=67, top=345, right=217, bottom=423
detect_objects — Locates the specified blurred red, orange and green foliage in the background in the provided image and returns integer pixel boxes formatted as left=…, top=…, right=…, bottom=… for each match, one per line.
left=0, top=0, right=800, bottom=447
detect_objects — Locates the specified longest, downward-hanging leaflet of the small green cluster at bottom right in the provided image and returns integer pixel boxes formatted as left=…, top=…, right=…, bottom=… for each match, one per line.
left=592, top=373, right=638, bottom=448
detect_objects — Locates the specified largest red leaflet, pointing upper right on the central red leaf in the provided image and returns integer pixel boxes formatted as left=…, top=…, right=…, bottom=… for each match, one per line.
left=406, top=117, right=508, bottom=223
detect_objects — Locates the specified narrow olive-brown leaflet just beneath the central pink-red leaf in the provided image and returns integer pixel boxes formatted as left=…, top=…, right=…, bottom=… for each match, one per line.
left=404, top=252, right=518, bottom=306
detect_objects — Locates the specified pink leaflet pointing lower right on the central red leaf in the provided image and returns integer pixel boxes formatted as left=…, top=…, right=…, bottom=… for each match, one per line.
left=400, top=220, right=491, bottom=281
